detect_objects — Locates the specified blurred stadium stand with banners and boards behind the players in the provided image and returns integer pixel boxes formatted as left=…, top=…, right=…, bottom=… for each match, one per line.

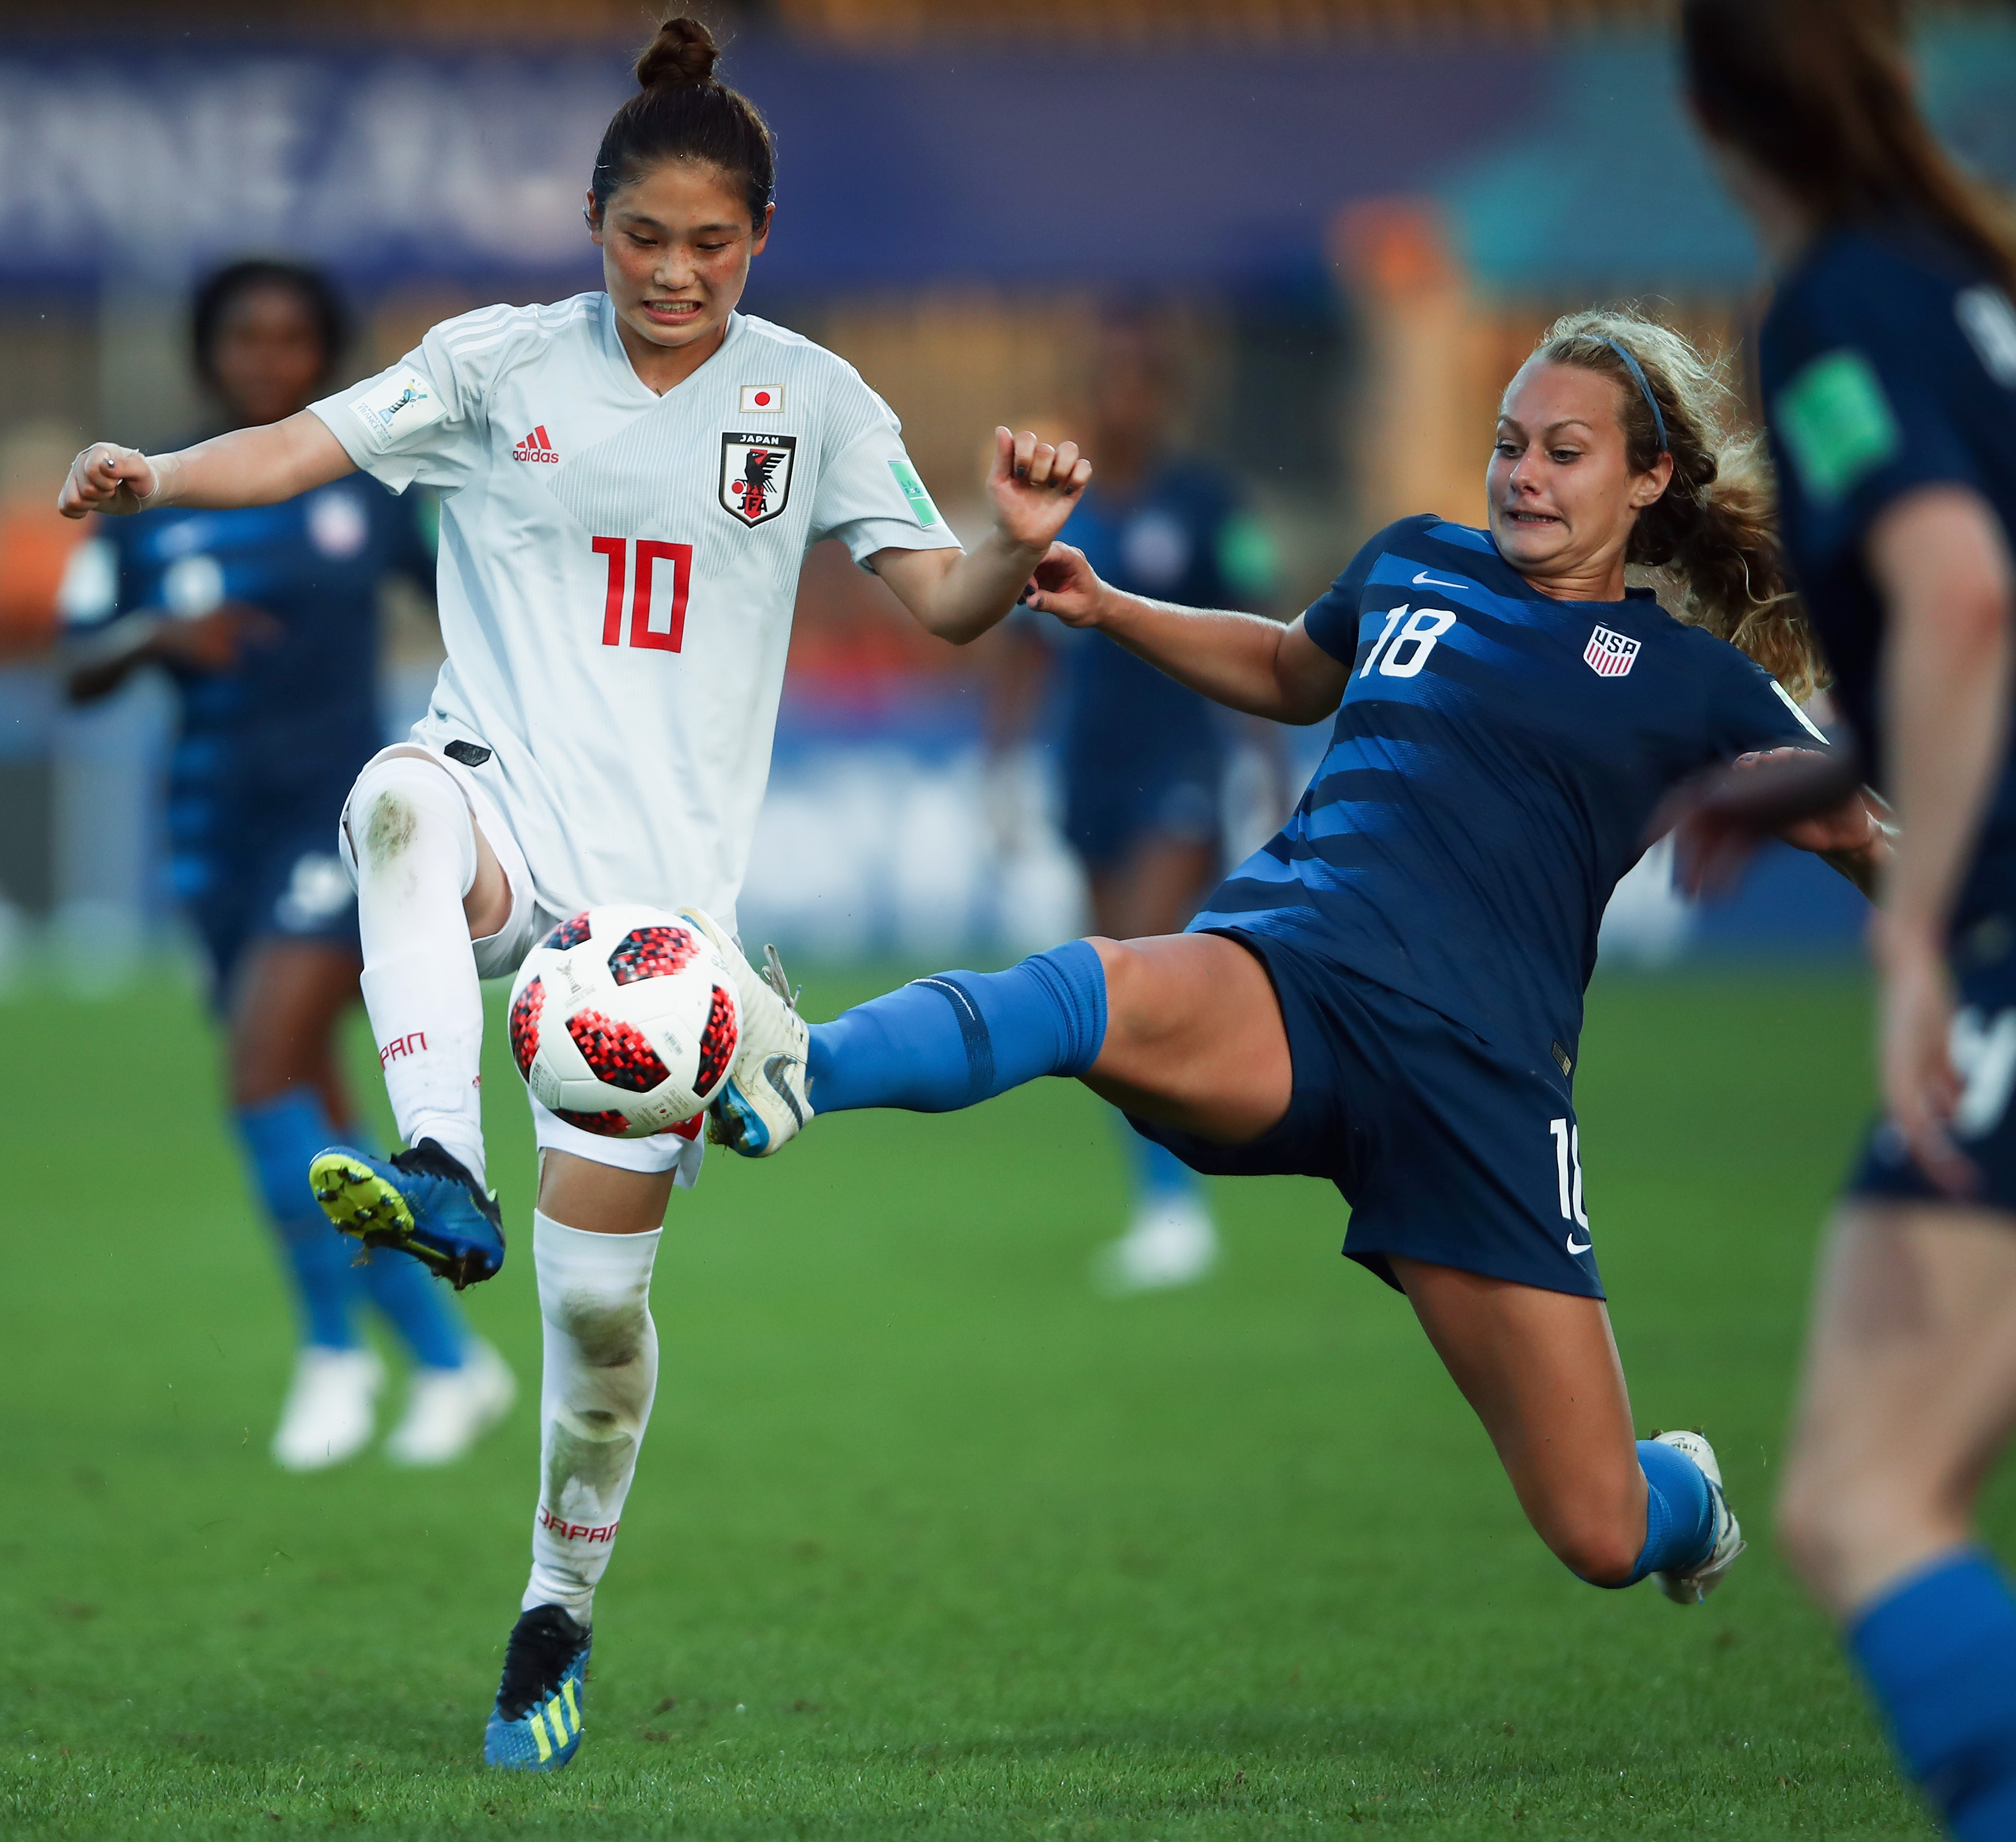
left=0, top=0, right=2016, bottom=975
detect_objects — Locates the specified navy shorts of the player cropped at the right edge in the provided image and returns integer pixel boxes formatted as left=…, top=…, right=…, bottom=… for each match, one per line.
left=1847, top=917, right=2016, bottom=1215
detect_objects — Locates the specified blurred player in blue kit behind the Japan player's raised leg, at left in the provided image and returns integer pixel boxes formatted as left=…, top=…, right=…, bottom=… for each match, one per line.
left=65, top=262, right=512, bottom=1471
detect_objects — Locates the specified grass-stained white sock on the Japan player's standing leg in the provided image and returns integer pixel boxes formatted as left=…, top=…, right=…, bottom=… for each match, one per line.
left=520, top=1209, right=664, bottom=1624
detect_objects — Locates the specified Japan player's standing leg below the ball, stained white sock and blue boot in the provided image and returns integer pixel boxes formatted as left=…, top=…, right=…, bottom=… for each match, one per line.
left=484, top=1140, right=676, bottom=1772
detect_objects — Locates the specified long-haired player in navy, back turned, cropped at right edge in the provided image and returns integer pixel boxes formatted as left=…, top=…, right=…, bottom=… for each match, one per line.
left=1681, top=0, right=2016, bottom=1842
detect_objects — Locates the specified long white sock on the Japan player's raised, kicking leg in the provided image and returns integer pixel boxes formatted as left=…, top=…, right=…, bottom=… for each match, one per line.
left=349, top=756, right=484, bottom=1185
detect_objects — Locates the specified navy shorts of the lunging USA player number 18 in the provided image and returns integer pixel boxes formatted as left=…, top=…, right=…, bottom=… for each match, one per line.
left=1133, top=927, right=1603, bottom=1298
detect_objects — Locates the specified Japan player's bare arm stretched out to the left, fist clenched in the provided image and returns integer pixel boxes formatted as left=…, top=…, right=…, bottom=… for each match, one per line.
left=56, top=409, right=357, bottom=518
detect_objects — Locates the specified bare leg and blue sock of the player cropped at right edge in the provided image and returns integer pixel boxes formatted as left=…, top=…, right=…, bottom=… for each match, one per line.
left=1778, top=1201, right=2016, bottom=1842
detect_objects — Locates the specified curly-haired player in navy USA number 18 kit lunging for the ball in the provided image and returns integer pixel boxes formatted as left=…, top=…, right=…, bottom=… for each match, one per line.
left=716, top=312, right=1885, bottom=1602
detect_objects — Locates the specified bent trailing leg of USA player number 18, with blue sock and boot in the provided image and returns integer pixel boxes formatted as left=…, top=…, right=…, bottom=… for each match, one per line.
left=1391, top=1256, right=1742, bottom=1602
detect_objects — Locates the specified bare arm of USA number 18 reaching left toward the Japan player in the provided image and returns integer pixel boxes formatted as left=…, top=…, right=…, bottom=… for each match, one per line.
left=1028, top=544, right=1351, bottom=723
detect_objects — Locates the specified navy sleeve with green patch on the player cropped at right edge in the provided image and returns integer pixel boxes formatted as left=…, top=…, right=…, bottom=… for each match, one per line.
left=1766, top=286, right=1998, bottom=570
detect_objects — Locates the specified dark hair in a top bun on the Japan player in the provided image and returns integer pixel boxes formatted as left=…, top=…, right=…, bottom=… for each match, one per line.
left=589, top=14, right=776, bottom=230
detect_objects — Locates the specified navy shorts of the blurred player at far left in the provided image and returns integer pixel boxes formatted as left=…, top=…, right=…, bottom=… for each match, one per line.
left=169, top=806, right=361, bottom=1006
